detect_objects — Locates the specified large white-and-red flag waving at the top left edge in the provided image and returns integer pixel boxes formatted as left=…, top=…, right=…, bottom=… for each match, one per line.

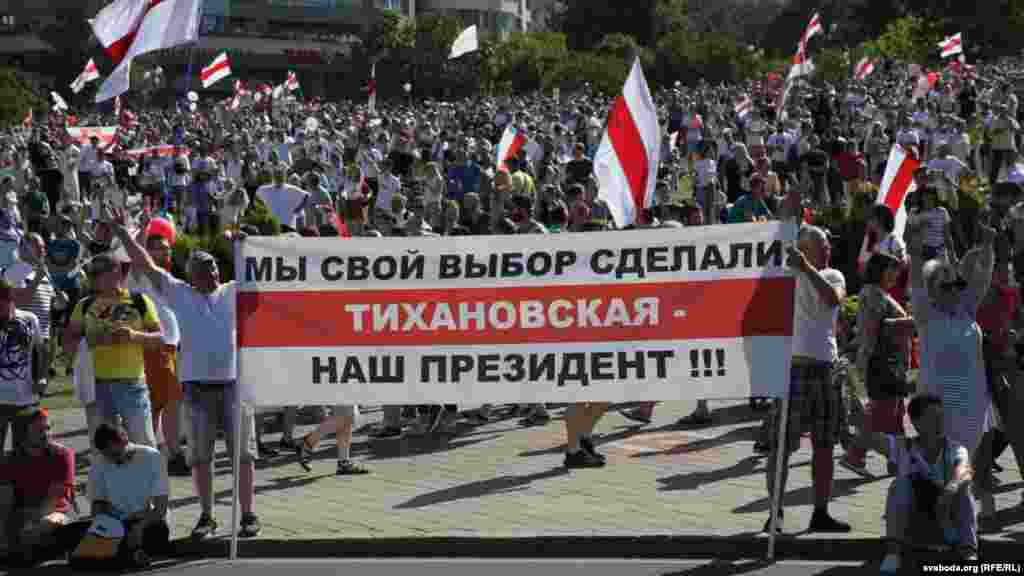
left=89, top=0, right=201, bottom=102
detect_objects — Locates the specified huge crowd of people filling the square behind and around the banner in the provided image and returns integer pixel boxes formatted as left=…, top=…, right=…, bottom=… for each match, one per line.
left=0, top=54, right=1024, bottom=573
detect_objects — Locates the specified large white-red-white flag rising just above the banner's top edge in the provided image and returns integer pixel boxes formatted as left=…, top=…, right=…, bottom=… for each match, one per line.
left=594, top=58, right=662, bottom=228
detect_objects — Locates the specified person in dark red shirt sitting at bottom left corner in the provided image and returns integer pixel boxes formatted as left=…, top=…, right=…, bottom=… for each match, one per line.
left=0, top=407, right=75, bottom=563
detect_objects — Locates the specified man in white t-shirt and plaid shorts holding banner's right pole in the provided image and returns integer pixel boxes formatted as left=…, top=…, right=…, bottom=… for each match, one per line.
left=765, top=227, right=850, bottom=533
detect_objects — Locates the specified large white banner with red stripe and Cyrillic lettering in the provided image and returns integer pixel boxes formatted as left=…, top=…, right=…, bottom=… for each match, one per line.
left=236, top=222, right=797, bottom=406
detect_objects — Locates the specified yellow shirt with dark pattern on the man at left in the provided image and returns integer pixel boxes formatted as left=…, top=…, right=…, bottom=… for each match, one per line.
left=71, top=290, right=160, bottom=380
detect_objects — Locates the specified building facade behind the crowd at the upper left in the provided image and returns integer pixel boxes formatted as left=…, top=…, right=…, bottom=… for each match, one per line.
left=0, top=0, right=554, bottom=100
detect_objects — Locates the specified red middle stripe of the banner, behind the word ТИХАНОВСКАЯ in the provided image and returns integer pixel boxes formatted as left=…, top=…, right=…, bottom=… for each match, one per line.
left=238, top=278, right=794, bottom=348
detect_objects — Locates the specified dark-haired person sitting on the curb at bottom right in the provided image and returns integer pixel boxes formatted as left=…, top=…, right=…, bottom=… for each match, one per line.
left=843, top=395, right=978, bottom=574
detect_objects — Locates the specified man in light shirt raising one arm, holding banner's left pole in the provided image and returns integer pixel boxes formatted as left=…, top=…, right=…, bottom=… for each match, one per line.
left=103, top=205, right=260, bottom=539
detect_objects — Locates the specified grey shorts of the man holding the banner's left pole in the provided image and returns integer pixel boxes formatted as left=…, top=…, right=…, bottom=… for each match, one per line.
left=184, top=381, right=256, bottom=465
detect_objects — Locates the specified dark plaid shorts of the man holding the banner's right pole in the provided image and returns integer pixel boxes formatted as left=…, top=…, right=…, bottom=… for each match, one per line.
left=771, top=360, right=845, bottom=452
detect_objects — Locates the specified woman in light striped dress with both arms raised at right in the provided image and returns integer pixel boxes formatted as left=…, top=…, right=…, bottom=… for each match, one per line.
left=905, top=216, right=995, bottom=508
